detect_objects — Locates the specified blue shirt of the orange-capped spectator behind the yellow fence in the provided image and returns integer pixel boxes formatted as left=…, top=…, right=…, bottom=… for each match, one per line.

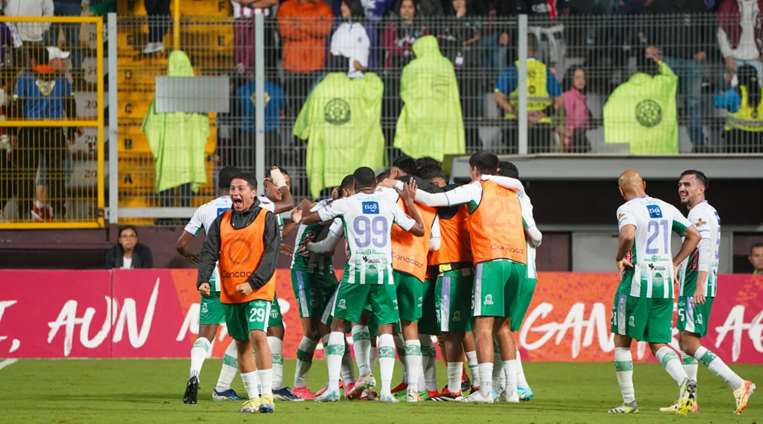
left=15, top=72, right=72, bottom=119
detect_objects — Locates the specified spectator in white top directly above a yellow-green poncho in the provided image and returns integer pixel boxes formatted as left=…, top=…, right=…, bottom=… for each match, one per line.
left=329, top=0, right=371, bottom=78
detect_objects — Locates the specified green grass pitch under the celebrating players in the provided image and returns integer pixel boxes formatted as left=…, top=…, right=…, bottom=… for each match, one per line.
left=0, top=360, right=763, bottom=424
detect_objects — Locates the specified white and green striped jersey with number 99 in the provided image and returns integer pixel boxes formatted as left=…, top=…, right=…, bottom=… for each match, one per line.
left=318, top=191, right=416, bottom=284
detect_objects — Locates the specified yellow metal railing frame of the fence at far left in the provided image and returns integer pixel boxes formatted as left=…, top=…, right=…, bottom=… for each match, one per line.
left=0, top=16, right=106, bottom=229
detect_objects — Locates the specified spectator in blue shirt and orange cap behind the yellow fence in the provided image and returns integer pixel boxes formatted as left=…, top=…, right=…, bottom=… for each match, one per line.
left=11, top=47, right=76, bottom=219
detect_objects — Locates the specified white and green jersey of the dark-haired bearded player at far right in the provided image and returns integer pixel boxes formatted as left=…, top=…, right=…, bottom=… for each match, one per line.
left=680, top=201, right=721, bottom=297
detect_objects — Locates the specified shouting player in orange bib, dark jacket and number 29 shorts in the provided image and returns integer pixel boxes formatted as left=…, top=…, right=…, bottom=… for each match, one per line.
left=197, top=173, right=280, bottom=413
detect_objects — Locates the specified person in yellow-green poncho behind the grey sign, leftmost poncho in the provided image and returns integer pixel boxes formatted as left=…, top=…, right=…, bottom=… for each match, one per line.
left=143, top=50, right=209, bottom=206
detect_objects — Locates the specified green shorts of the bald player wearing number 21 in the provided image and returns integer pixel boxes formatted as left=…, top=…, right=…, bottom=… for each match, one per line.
left=611, top=270, right=673, bottom=343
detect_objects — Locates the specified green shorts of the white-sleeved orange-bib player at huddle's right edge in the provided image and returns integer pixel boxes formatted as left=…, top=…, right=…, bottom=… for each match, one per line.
left=473, top=259, right=527, bottom=318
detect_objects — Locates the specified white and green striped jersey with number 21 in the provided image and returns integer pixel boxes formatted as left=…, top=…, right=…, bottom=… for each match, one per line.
left=617, top=196, right=691, bottom=299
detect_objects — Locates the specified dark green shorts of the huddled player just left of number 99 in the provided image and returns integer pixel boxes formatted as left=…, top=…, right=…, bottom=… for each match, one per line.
left=291, top=269, right=339, bottom=318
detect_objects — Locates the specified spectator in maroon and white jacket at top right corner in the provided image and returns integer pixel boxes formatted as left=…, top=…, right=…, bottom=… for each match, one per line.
left=717, top=0, right=763, bottom=79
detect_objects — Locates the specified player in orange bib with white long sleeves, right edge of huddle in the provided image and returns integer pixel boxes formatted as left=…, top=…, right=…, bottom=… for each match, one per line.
left=384, top=152, right=527, bottom=403
